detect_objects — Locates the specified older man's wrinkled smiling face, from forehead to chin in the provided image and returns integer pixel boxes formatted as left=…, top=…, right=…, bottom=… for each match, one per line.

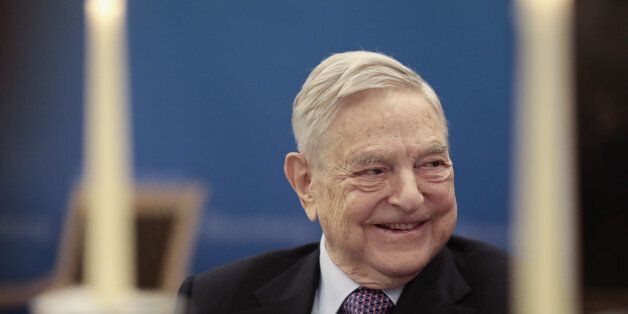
left=311, top=89, right=456, bottom=288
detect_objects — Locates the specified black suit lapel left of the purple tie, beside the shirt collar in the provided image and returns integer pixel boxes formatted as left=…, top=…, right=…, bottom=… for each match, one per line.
left=242, top=249, right=320, bottom=314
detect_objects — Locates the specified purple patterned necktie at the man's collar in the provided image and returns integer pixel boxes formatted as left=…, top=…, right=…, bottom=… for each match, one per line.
left=340, top=287, right=395, bottom=314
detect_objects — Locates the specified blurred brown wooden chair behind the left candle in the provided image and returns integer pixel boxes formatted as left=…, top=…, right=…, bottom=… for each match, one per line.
left=0, top=183, right=207, bottom=306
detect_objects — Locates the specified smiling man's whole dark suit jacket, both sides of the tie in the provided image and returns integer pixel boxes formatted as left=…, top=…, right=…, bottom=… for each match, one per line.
left=179, top=236, right=508, bottom=314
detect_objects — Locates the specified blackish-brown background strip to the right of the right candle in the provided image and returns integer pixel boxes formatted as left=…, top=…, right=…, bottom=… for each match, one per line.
left=575, top=0, right=628, bottom=313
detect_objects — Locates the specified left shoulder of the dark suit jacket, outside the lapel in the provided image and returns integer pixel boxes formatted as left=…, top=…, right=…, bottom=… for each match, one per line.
left=179, top=243, right=318, bottom=314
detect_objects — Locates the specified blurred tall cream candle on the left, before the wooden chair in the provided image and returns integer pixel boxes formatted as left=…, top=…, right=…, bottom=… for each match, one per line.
left=84, top=0, right=135, bottom=306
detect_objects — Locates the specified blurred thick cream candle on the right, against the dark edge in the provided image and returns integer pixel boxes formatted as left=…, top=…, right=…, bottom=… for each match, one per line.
left=513, top=0, right=578, bottom=314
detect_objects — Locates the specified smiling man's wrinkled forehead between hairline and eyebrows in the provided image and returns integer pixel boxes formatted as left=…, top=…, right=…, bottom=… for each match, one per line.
left=312, top=89, right=447, bottom=163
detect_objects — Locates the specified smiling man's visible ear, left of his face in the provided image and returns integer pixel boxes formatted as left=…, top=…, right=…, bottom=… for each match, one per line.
left=283, top=152, right=317, bottom=221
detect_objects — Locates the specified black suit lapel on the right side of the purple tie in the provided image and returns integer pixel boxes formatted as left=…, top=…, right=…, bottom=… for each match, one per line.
left=393, top=247, right=475, bottom=314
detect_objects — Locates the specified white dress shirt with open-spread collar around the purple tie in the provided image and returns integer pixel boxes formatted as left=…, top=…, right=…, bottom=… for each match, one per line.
left=312, top=234, right=405, bottom=314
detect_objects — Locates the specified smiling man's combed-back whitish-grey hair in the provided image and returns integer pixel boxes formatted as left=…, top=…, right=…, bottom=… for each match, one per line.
left=292, top=51, right=448, bottom=156
